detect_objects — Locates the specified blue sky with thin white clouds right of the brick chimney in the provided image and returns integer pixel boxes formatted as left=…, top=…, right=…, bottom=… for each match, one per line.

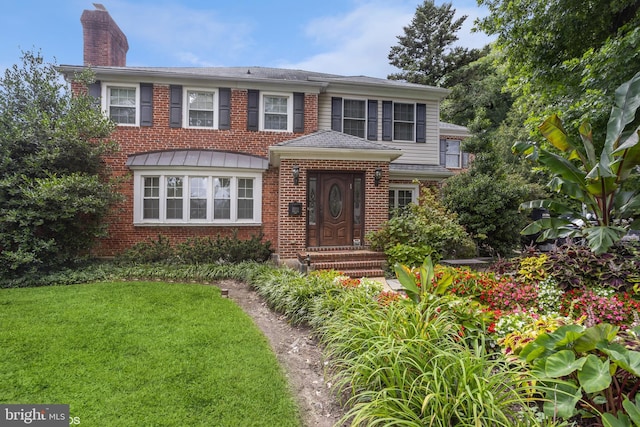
left=97, top=0, right=488, bottom=78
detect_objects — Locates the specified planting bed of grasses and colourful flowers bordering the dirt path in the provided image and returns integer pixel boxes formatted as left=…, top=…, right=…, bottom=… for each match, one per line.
left=6, top=239, right=640, bottom=427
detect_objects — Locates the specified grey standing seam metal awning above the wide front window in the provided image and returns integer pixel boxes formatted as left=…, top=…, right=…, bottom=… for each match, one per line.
left=126, top=150, right=269, bottom=170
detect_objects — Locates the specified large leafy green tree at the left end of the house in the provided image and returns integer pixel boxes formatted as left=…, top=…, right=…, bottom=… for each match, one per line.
left=0, top=52, right=118, bottom=276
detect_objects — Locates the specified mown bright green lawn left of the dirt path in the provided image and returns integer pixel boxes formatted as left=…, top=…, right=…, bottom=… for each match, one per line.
left=0, top=282, right=301, bottom=427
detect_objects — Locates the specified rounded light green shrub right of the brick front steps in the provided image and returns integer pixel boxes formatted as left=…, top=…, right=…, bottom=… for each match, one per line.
left=367, top=189, right=476, bottom=258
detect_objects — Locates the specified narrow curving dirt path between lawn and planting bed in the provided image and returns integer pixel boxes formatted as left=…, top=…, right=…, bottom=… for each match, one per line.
left=216, top=280, right=344, bottom=427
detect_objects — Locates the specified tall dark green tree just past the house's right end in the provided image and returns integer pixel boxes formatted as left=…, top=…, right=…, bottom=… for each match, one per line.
left=442, top=51, right=540, bottom=256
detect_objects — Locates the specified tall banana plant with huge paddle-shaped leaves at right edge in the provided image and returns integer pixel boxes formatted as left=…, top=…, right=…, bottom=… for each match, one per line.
left=513, top=72, right=640, bottom=254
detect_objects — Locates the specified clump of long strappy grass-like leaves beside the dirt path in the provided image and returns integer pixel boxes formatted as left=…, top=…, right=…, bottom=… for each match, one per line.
left=320, top=294, right=534, bottom=427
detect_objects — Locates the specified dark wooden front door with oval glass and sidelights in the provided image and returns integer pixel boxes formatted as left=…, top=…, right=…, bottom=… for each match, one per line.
left=307, top=172, right=364, bottom=246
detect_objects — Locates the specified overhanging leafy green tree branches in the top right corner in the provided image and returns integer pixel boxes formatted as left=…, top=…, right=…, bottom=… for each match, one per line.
left=479, top=0, right=640, bottom=148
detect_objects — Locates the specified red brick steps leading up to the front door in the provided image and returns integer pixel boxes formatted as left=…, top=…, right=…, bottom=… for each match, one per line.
left=298, top=246, right=386, bottom=278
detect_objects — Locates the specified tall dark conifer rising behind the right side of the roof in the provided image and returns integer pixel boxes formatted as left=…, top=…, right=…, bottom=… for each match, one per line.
left=388, top=0, right=480, bottom=86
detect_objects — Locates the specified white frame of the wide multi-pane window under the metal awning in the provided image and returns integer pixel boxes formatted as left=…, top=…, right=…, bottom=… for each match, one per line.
left=133, top=169, right=262, bottom=226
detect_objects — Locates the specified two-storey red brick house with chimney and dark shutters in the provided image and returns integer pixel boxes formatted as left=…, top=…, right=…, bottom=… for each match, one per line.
left=58, top=5, right=468, bottom=274
